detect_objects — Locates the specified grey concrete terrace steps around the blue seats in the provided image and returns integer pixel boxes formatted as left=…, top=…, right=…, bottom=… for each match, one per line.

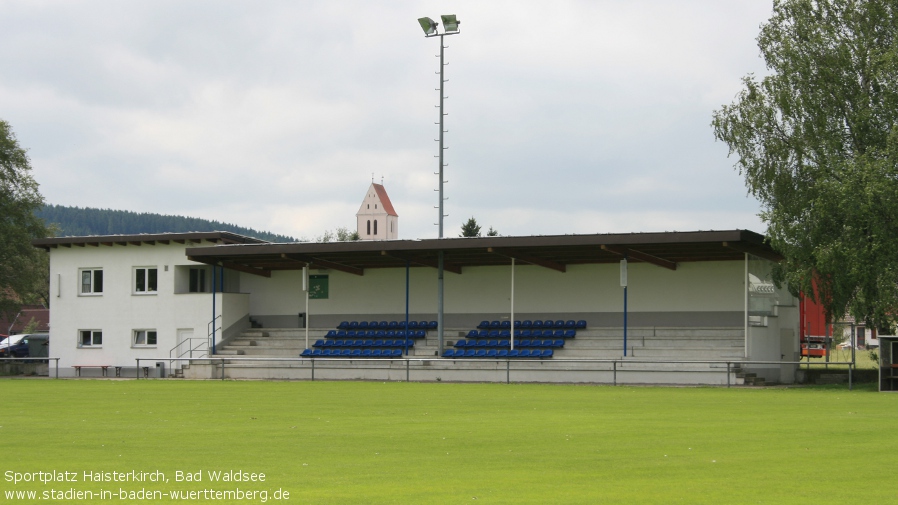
left=174, top=328, right=763, bottom=385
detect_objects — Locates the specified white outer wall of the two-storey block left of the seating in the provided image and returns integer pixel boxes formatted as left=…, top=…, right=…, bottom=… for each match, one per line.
left=50, top=243, right=234, bottom=375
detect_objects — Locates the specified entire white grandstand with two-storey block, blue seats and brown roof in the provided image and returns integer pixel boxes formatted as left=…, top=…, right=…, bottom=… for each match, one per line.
left=35, top=230, right=798, bottom=384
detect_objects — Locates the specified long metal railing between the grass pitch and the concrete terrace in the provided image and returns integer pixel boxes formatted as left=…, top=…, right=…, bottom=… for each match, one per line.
left=135, top=356, right=855, bottom=390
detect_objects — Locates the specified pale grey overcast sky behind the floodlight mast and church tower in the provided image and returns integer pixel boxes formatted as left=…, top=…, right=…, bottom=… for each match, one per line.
left=0, top=0, right=772, bottom=239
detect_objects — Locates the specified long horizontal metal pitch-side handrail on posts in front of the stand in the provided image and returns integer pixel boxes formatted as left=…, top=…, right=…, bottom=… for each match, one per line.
left=135, top=356, right=855, bottom=390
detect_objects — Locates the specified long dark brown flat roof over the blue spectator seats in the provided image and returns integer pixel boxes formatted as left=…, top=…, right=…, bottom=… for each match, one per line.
left=187, top=230, right=782, bottom=276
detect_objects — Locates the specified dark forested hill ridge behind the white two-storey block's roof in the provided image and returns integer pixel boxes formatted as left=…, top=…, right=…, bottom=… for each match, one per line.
left=36, top=205, right=297, bottom=242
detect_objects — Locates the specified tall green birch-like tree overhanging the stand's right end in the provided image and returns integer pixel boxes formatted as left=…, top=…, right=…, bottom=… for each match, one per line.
left=712, top=0, right=898, bottom=324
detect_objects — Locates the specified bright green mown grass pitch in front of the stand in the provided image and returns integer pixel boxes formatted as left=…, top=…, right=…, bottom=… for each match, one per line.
left=0, top=379, right=898, bottom=505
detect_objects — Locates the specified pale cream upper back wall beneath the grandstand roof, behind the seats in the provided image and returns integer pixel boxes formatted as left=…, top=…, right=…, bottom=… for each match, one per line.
left=234, top=261, right=744, bottom=315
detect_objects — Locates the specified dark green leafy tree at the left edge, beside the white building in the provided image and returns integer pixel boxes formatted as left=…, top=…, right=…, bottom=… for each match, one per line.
left=0, top=120, right=49, bottom=317
